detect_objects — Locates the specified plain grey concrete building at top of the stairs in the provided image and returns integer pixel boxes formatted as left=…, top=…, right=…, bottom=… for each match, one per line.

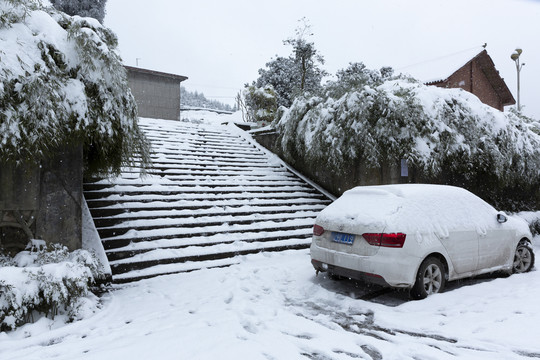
left=126, top=66, right=187, bottom=120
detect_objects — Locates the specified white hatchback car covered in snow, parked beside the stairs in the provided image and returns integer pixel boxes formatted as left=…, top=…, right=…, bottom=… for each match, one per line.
left=311, top=184, right=534, bottom=299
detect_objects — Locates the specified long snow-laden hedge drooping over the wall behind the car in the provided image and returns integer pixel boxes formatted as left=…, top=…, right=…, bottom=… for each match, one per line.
left=276, top=64, right=540, bottom=210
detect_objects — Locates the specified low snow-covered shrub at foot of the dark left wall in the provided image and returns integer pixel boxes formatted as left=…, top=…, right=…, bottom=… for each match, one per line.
left=0, top=241, right=104, bottom=331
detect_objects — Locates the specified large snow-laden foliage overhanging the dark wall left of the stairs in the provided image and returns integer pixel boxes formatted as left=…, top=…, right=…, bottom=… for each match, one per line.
left=0, top=0, right=149, bottom=173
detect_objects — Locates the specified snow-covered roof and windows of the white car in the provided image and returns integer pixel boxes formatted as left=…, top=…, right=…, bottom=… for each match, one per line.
left=318, top=184, right=496, bottom=236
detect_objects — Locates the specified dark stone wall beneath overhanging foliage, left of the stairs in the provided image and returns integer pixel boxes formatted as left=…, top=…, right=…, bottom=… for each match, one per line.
left=0, top=146, right=83, bottom=254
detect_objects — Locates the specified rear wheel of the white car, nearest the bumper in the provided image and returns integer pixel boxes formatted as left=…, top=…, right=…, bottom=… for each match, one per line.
left=411, top=257, right=446, bottom=299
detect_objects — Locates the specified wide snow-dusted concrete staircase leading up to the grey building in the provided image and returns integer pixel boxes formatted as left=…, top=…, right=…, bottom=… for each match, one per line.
left=84, top=119, right=330, bottom=283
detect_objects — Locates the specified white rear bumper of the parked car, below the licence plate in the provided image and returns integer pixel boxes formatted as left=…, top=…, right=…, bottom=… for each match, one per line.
left=311, top=242, right=420, bottom=288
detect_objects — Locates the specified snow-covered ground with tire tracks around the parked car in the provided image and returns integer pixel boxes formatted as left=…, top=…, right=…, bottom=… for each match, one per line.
left=0, top=238, right=540, bottom=360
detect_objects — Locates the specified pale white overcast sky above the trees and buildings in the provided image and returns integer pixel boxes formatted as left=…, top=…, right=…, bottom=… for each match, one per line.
left=105, top=0, right=540, bottom=119
